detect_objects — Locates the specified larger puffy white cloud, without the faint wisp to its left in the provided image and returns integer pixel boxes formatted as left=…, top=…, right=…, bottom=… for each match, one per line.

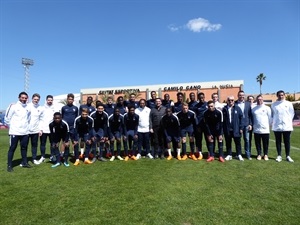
left=186, top=18, right=222, bottom=32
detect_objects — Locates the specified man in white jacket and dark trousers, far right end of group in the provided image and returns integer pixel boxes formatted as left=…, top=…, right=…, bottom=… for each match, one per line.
left=271, top=90, right=295, bottom=162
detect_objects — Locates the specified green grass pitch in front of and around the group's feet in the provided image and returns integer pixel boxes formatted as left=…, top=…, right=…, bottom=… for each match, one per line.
left=0, top=127, right=300, bottom=225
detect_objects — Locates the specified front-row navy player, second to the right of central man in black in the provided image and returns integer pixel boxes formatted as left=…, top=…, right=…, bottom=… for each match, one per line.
left=176, top=102, right=197, bottom=160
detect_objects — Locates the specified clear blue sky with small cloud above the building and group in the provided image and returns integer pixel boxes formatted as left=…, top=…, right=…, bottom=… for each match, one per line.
left=0, top=0, right=300, bottom=109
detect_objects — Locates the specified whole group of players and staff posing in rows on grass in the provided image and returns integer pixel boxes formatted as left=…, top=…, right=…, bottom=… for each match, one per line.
left=5, top=90, right=294, bottom=172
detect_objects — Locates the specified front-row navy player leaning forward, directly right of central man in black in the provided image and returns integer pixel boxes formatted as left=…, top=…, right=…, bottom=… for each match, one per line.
left=161, top=108, right=181, bottom=160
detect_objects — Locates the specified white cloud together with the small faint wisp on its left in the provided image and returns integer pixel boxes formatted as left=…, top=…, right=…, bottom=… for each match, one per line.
left=168, top=17, right=222, bottom=33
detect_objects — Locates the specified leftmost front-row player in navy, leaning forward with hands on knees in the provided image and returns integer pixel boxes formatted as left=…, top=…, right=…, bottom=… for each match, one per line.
left=49, top=112, right=70, bottom=168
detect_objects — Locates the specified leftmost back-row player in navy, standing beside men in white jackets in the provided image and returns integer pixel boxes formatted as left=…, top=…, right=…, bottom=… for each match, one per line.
left=61, top=94, right=78, bottom=156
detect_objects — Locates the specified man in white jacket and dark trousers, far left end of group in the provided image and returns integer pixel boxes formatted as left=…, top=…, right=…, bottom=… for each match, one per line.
left=5, top=92, right=31, bottom=172
